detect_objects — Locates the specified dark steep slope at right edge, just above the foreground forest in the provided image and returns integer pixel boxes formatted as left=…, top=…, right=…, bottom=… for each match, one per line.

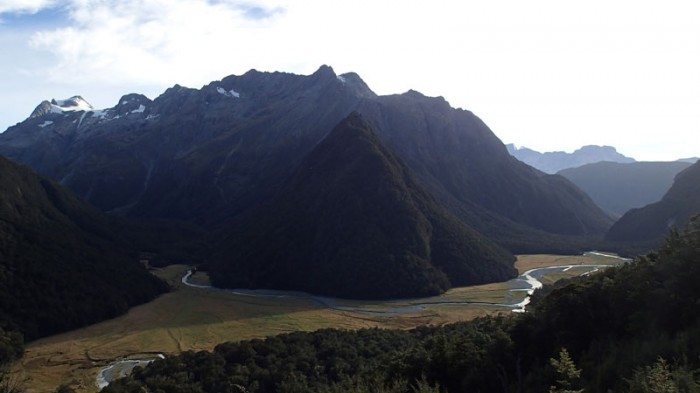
left=606, top=158, right=700, bottom=245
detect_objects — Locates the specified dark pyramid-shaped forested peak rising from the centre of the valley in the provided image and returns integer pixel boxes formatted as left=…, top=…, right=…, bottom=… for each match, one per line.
left=210, top=113, right=516, bottom=298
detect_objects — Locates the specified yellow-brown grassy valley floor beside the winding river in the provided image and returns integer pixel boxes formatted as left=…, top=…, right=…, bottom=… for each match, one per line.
left=8, top=254, right=621, bottom=393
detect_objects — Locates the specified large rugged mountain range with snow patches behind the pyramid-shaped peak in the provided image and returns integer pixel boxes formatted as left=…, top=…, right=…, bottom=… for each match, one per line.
left=0, top=66, right=612, bottom=252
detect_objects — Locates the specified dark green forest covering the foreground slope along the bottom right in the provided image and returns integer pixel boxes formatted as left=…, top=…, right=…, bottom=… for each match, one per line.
left=103, top=217, right=700, bottom=393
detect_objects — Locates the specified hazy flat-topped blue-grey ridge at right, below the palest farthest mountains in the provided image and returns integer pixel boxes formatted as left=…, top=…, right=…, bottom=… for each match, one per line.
left=558, top=161, right=690, bottom=217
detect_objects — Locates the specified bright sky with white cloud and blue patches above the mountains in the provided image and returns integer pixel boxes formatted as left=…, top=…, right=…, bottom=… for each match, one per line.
left=0, top=0, right=700, bottom=161
